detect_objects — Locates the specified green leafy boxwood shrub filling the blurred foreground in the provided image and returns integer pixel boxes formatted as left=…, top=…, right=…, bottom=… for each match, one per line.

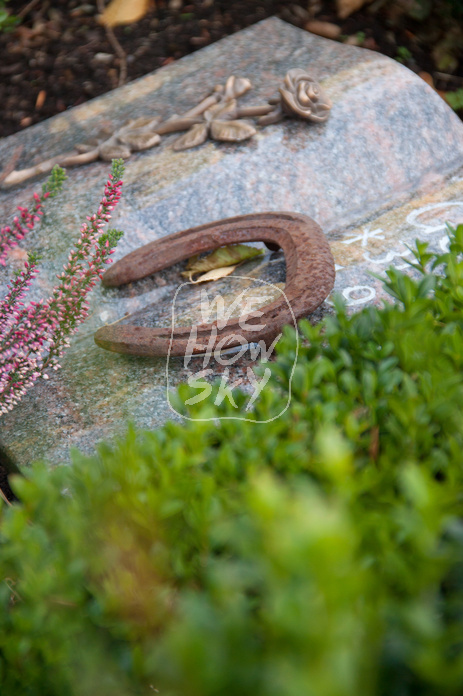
left=0, top=226, right=463, bottom=696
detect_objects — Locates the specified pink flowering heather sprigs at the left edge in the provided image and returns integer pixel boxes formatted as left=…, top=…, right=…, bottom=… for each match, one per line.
left=0, top=160, right=124, bottom=415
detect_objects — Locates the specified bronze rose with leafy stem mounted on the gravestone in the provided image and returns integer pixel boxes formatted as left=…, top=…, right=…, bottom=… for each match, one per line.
left=0, top=68, right=332, bottom=188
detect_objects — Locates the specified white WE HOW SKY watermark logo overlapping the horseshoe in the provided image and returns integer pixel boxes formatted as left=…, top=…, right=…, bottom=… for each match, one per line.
left=166, top=276, right=299, bottom=423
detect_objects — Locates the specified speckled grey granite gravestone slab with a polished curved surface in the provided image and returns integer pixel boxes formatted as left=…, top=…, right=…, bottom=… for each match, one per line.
left=0, top=19, right=463, bottom=465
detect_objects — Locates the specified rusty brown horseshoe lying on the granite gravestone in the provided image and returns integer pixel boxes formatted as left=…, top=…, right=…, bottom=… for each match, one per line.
left=95, top=212, right=335, bottom=356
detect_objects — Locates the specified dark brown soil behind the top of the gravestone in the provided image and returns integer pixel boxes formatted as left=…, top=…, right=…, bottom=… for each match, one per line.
left=0, top=0, right=463, bottom=137
